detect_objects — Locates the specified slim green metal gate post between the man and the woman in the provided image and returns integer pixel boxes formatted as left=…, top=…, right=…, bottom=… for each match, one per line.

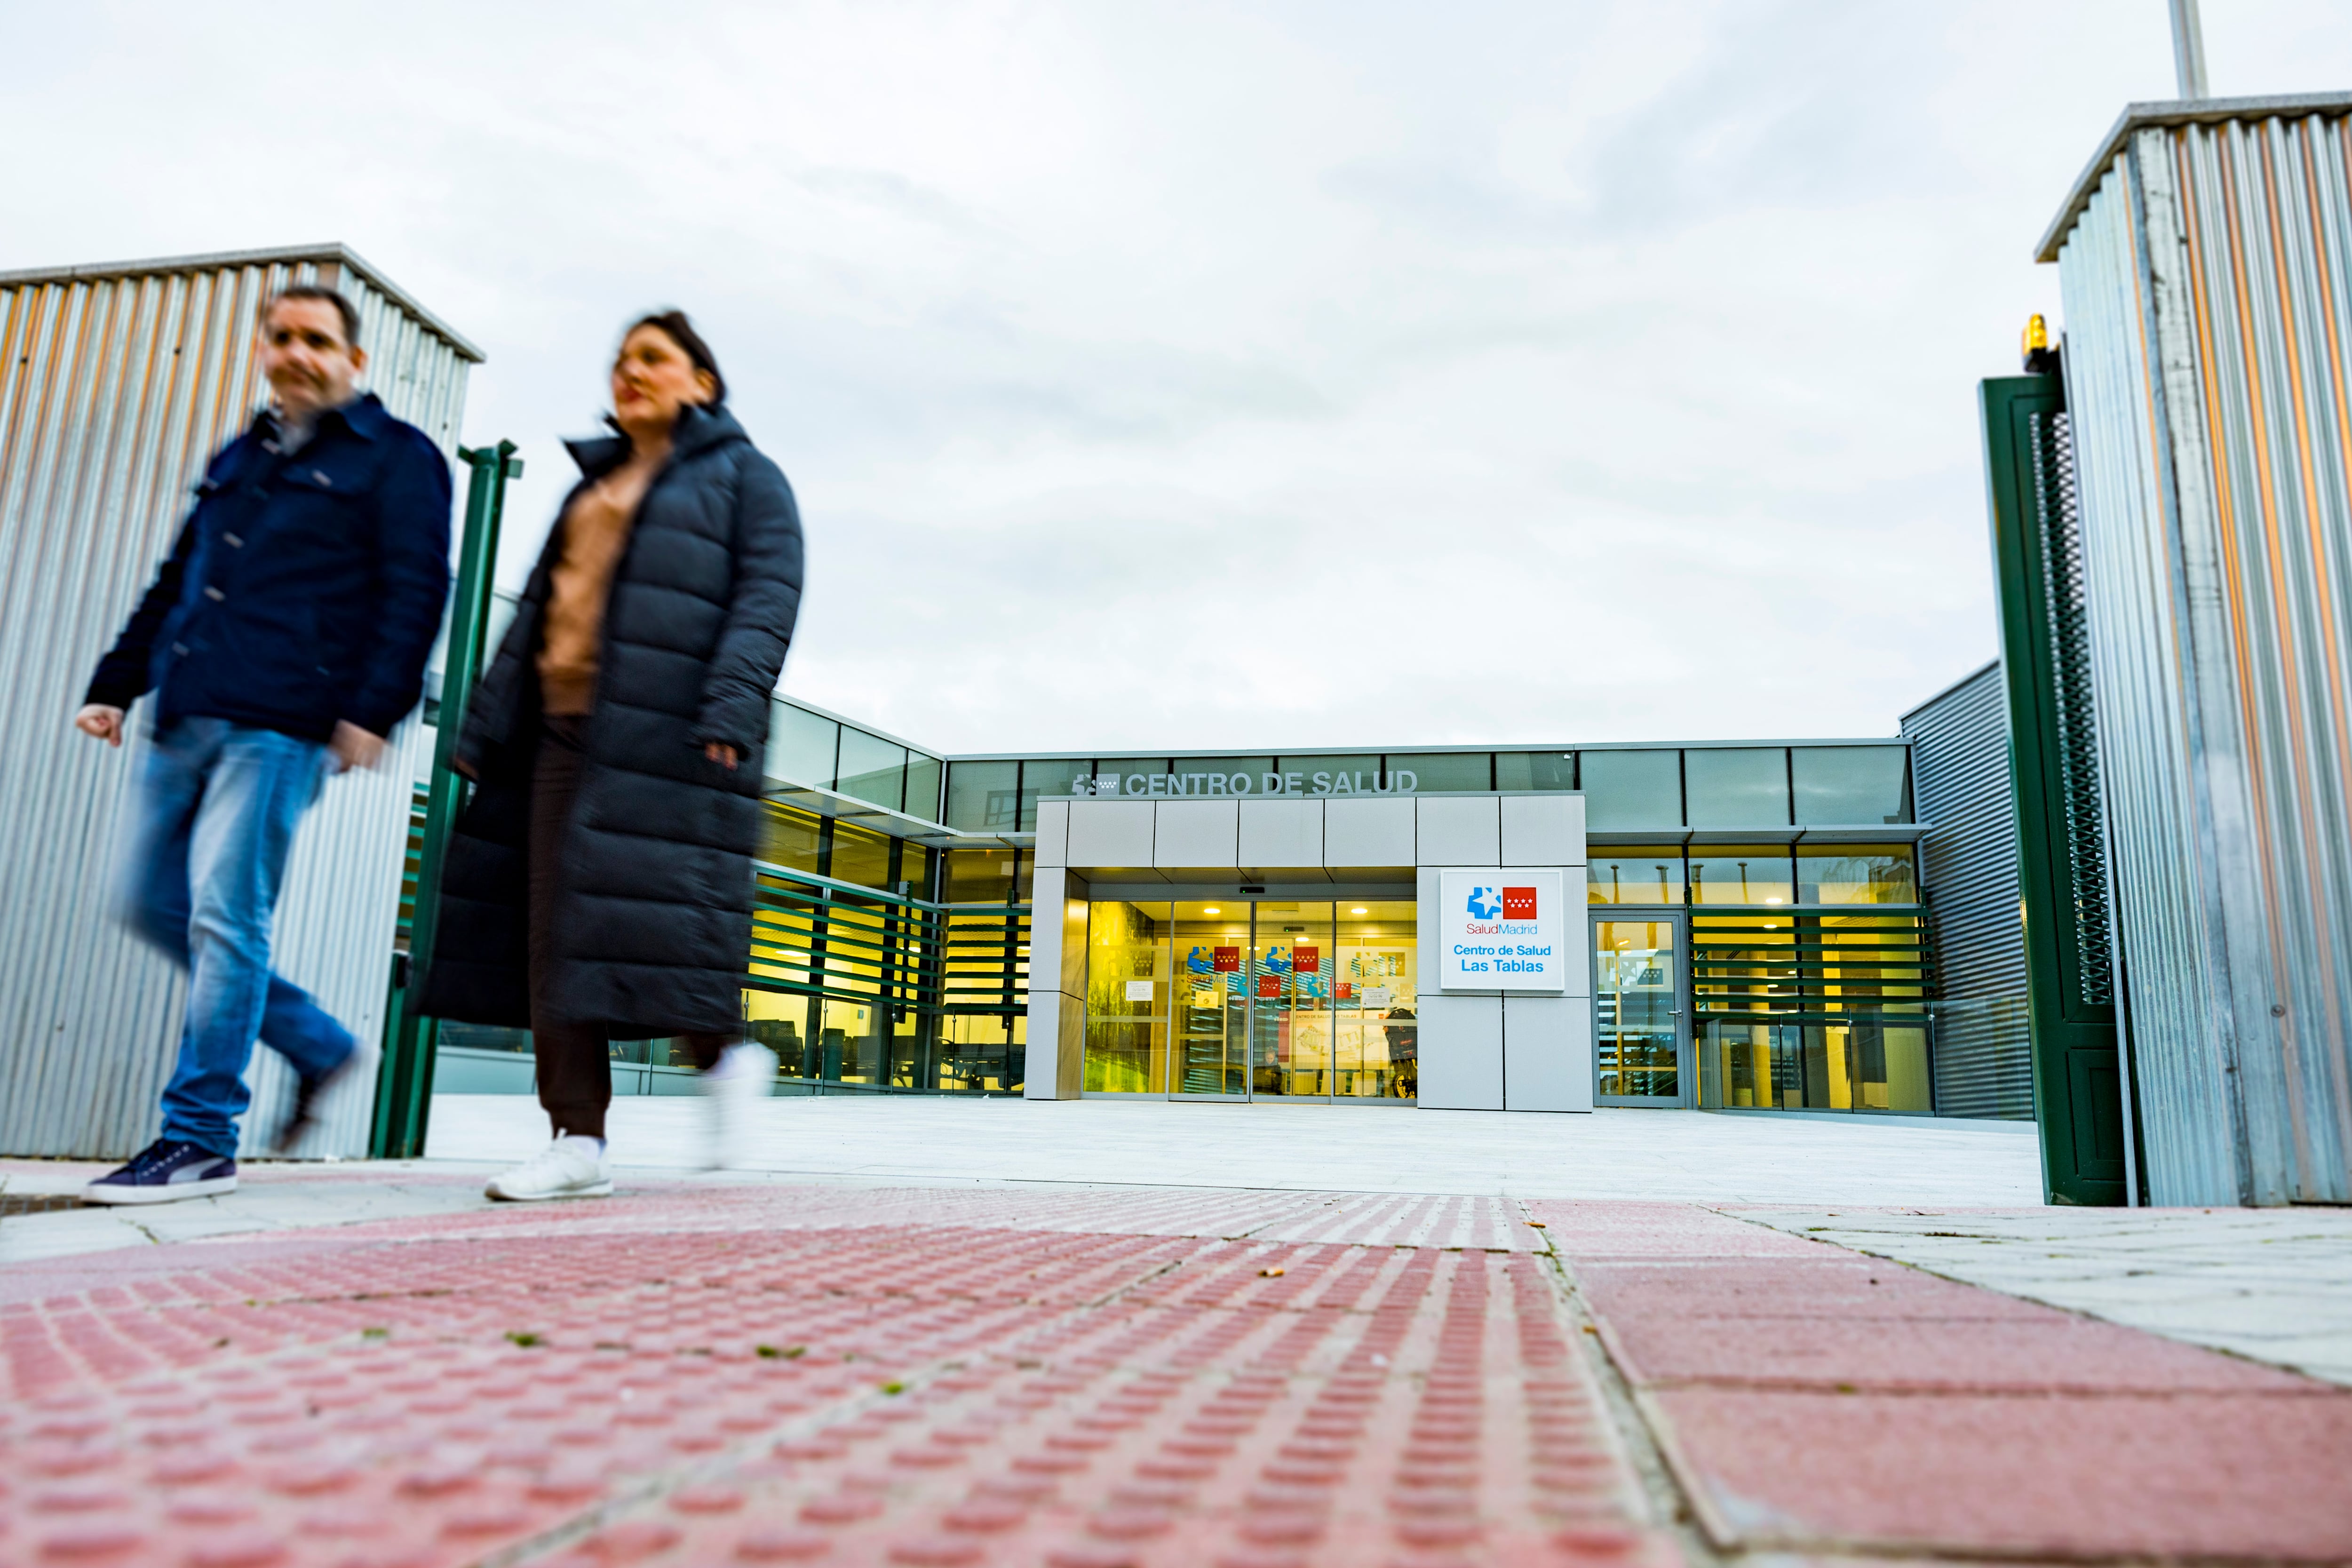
left=367, top=442, right=522, bottom=1159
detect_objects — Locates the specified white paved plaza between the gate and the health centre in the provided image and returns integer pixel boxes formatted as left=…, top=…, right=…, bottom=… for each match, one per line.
left=428, top=1096, right=2042, bottom=1208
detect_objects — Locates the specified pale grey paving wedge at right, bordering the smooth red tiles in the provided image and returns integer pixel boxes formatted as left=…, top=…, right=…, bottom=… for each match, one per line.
left=1726, top=1206, right=2352, bottom=1385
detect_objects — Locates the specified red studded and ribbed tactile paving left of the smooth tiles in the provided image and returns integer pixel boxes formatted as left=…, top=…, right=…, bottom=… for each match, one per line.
left=0, top=1189, right=1677, bottom=1568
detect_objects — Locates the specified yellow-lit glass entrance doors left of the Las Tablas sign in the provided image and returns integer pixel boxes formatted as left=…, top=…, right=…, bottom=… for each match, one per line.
left=1084, top=898, right=1421, bottom=1100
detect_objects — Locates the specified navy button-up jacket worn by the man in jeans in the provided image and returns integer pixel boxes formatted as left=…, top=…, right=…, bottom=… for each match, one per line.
left=85, top=395, right=449, bottom=740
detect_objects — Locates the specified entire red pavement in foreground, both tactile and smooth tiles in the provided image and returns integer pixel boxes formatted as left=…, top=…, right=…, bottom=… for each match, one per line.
left=0, top=1171, right=2352, bottom=1568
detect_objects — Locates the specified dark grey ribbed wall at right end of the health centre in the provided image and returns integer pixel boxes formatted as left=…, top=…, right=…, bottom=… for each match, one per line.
left=1903, top=661, right=2034, bottom=1122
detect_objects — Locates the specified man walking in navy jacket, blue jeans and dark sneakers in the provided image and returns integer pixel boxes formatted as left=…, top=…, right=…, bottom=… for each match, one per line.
left=73, top=285, right=449, bottom=1203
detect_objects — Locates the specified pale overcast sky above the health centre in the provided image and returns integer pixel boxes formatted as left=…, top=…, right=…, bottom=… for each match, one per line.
left=0, top=0, right=2352, bottom=752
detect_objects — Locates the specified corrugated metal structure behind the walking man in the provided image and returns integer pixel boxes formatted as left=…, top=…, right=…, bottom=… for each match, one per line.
left=0, top=245, right=482, bottom=1157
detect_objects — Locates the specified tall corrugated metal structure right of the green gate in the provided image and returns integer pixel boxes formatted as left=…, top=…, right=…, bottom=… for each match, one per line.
left=2039, top=94, right=2352, bottom=1203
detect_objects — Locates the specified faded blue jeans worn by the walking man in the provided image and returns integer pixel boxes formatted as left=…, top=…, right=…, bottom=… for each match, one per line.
left=122, top=719, right=358, bottom=1157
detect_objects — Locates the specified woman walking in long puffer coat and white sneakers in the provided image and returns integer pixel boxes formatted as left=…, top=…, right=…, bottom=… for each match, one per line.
left=416, top=310, right=802, bottom=1201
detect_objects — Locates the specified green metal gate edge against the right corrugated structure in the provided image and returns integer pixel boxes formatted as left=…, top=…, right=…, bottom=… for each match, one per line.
left=1980, top=374, right=2126, bottom=1203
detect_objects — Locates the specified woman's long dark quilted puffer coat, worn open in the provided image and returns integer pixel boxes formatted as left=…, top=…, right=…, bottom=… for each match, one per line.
left=412, top=406, right=802, bottom=1039
